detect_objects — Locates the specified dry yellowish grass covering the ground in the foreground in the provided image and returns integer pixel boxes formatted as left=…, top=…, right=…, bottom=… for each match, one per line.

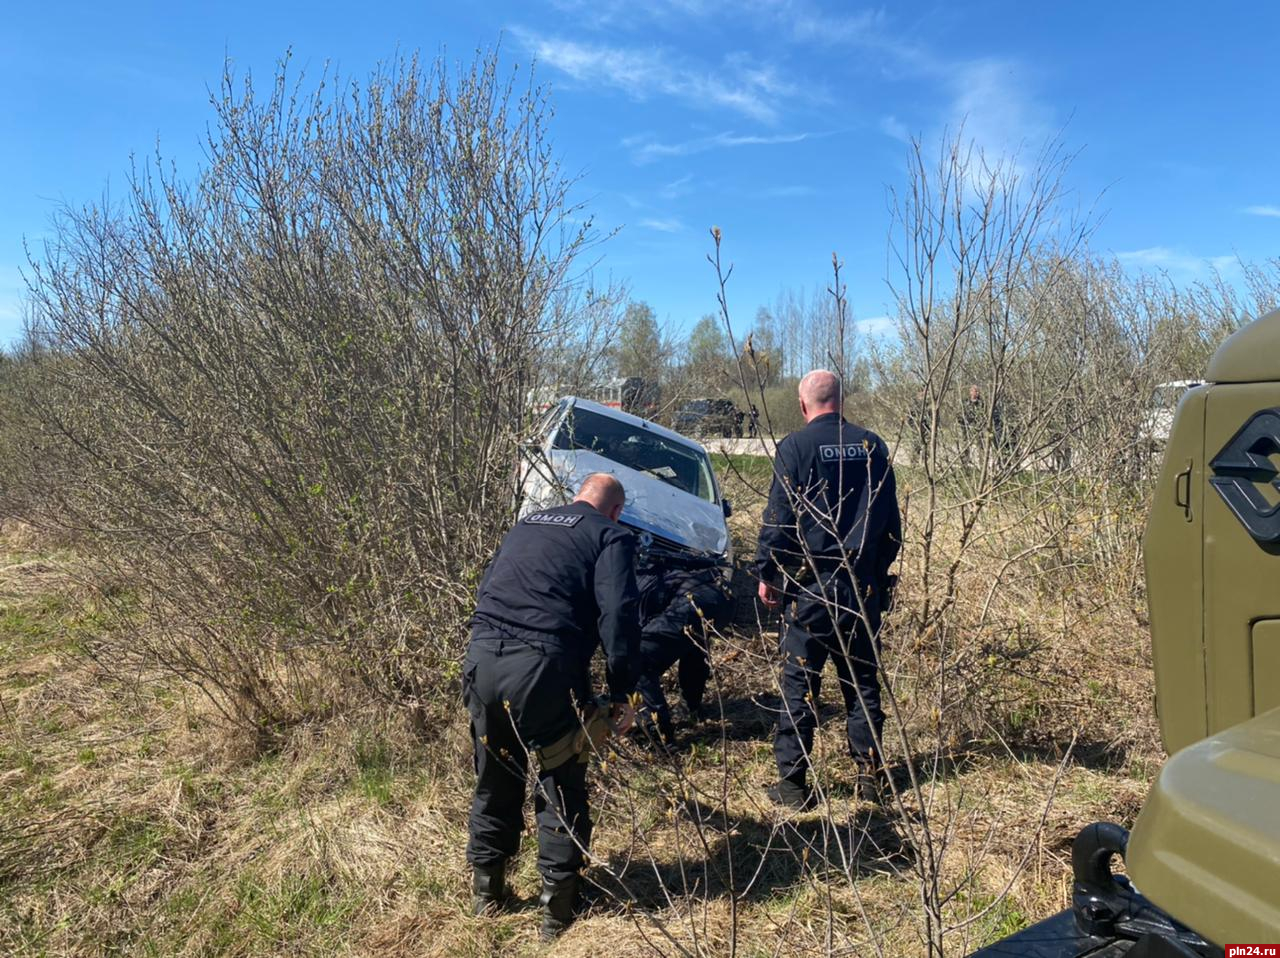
left=0, top=471, right=1158, bottom=955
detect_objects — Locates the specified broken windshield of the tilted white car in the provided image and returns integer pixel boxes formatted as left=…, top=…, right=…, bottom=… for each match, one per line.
left=554, top=409, right=716, bottom=502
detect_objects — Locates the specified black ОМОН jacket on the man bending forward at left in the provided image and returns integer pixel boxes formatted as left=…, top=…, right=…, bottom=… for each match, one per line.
left=471, top=502, right=640, bottom=702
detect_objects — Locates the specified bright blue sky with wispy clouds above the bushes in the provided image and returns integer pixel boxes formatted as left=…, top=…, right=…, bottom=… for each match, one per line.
left=0, top=0, right=1280, bottom=342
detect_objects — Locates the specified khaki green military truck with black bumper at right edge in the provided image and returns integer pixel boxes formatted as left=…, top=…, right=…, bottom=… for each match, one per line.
left=978, top=310, right=1280, bottom=958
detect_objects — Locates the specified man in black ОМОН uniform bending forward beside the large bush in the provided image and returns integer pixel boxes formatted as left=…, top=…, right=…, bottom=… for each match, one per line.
left=462, top=473, right=640, bottom=938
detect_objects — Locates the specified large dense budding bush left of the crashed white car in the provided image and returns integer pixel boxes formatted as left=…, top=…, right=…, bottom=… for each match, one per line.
left=10, top=55, right=614, bottom=729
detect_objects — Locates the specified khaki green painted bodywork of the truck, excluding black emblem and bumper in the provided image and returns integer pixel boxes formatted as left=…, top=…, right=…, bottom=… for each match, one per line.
left=1125, top=311, right=1280, bottom=945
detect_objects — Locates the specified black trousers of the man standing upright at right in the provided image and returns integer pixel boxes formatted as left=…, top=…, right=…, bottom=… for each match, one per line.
left=773, top=571, right=884, bottom=779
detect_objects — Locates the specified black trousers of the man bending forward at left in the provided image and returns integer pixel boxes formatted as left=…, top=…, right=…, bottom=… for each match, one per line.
left=462, top=638, right=591, bottom=882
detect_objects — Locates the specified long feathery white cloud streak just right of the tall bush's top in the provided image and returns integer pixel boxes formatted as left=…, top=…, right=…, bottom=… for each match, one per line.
left=512, top=28, right=800, bottom=123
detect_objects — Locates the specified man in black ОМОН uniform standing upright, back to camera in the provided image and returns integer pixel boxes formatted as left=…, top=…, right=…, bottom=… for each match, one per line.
left=756, top=369, right=902, bottom=808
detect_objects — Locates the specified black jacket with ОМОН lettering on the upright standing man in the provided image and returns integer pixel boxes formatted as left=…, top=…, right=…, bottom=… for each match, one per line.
left=755, top=412, right=902, bottom=587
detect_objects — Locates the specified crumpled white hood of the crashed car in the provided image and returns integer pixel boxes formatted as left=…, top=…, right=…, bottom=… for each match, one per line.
left=548, top=450, right=728, bottom=555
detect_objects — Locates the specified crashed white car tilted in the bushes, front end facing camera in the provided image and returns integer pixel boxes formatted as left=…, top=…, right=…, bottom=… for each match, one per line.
left=520, top=396, right=732, bottom=570
